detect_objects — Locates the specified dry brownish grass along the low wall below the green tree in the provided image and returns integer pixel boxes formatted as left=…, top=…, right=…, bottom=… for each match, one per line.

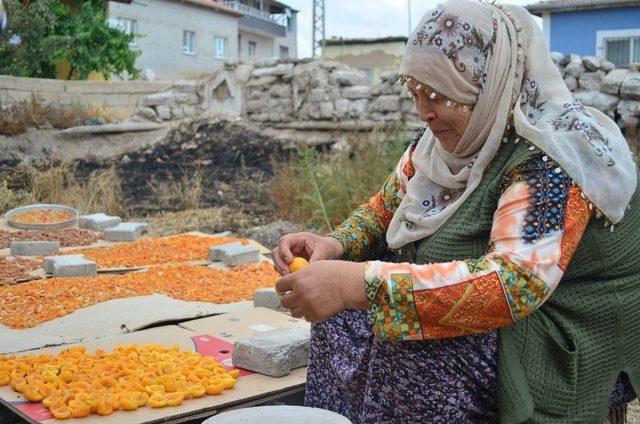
left=0, top=95, right=127, bottom=135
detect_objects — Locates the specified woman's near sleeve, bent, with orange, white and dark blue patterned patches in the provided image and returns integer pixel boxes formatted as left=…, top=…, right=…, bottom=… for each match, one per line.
left=365, top=154, right=592, bottom=341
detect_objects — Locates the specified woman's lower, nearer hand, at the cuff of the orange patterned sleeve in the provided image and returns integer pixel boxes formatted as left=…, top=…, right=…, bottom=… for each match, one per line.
left=276, top=261, right=369, bottom=322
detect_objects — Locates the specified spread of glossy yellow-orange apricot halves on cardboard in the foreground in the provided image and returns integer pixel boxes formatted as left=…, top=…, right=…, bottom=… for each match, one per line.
left=0, top=344, right=240, bottom=420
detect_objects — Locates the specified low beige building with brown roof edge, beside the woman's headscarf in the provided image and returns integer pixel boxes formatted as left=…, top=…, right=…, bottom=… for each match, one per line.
left=322, top=37, right=407, bottom=84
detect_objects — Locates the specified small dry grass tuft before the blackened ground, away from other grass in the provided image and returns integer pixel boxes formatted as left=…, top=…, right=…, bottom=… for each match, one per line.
left=148, top=169, right=203, bottom=210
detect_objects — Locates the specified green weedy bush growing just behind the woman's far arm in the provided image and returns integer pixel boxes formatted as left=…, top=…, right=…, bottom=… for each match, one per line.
left=270, top=127, right=408, bottom=232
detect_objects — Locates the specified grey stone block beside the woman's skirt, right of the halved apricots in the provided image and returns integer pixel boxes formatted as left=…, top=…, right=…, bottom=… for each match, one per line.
left=232, top=328, right=311, bottom=377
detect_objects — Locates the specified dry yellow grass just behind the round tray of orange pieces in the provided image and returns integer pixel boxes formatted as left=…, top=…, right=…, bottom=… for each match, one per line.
left=0, top=163, right=127, bottom=216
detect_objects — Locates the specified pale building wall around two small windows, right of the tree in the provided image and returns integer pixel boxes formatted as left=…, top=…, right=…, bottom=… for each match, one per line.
left=109, top=0, right=238, bottom=80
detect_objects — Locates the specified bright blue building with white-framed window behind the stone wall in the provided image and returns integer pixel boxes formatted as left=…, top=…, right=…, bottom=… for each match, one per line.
left=526, top=0, right=640, bottom=66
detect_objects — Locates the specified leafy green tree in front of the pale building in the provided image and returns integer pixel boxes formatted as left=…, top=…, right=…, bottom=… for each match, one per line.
left=0, top=0, right=140, bottom=79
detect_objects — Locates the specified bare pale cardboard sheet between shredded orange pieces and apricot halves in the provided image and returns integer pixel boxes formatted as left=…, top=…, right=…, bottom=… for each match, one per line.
left=0, top=294, right=253, bottom=354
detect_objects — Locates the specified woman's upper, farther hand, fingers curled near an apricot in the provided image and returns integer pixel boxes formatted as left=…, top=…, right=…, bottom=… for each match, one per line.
left=271, top=233, right=344, bottom=275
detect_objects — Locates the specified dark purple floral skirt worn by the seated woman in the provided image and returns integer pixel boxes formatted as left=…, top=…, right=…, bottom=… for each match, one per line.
left=305, top=310, right=635, bottom=424
